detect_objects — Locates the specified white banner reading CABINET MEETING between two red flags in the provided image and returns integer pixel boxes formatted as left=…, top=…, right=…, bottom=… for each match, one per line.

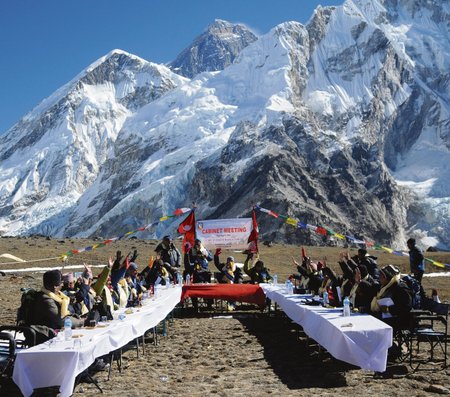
left=196, top=218, right=252, bottom=250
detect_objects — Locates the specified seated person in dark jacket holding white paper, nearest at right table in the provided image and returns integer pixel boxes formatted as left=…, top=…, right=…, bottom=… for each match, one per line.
left=370, top=265, right=412, bottom=331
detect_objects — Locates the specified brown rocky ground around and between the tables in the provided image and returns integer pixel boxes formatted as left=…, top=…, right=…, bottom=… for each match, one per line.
left=0, top=237, right=450, bottom=397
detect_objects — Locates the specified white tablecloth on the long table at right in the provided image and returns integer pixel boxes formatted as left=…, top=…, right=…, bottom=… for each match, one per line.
left=260, top=284, right=392, bottom=372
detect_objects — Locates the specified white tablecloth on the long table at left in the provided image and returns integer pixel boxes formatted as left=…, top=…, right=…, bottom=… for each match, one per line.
left=13, top=287, right=181, bottom=397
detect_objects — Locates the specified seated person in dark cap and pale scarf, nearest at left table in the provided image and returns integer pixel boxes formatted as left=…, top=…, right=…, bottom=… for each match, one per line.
left=28, top=270, right=84, bottom=329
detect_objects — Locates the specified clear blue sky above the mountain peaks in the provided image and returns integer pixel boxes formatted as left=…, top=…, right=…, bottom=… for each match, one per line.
left=0, top=0, right=343, bottom=134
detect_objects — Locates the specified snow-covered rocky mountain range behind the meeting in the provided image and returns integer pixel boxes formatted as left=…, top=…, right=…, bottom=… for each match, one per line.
left=0, top=0, right=450, bottom=248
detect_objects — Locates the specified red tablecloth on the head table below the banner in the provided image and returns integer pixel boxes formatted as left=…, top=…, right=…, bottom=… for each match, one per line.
left=181, top=284, right=266, bottom=306
